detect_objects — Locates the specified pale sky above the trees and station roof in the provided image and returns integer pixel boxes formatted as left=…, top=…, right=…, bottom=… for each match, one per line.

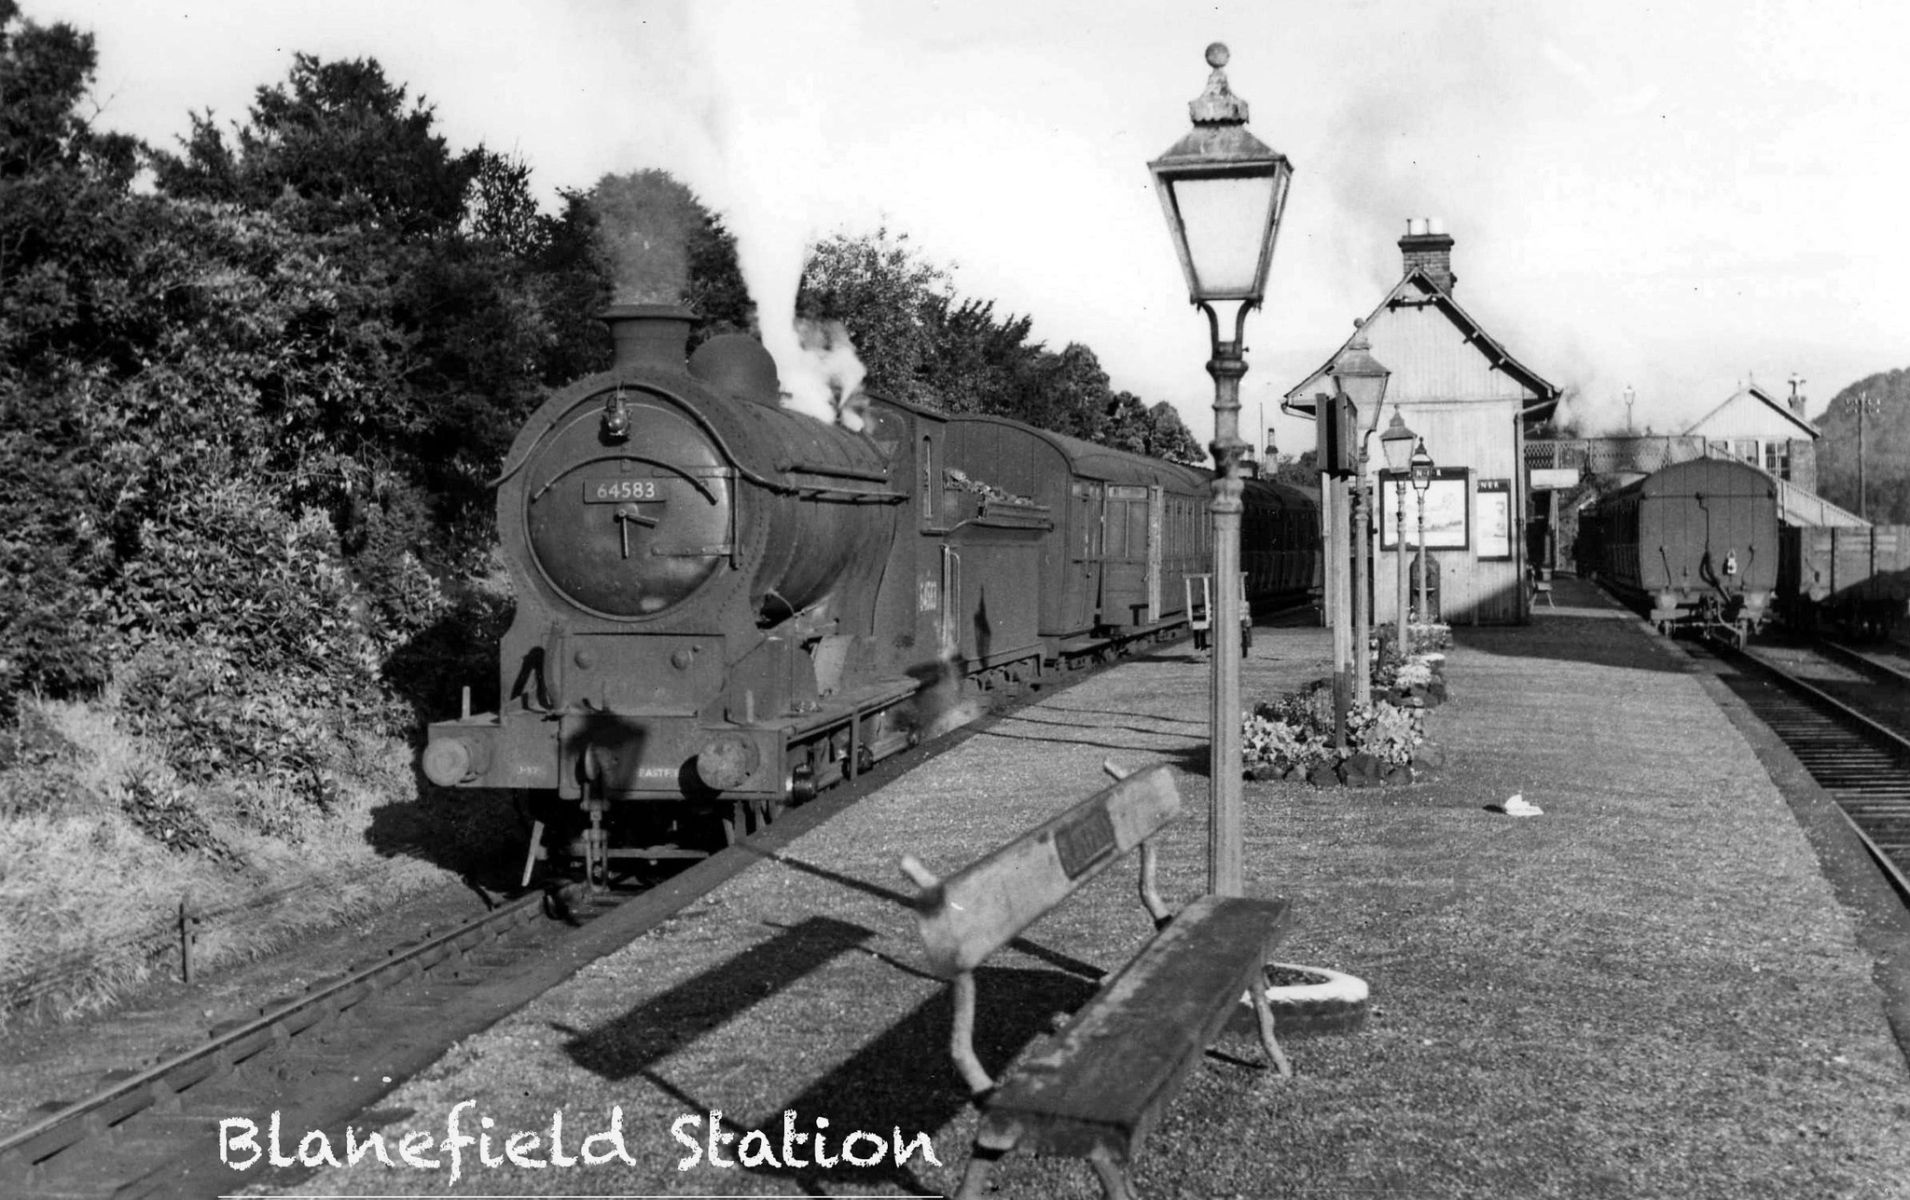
left=23, top=0, right=1910, bottom=453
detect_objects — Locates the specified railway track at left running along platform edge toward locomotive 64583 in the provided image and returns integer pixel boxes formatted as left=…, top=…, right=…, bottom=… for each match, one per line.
left=0, top=613, right=1230, bottom=1200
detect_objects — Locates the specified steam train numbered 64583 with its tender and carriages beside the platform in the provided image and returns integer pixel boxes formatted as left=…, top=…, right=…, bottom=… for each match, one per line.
left=422, top=306, right=1320, bottom=877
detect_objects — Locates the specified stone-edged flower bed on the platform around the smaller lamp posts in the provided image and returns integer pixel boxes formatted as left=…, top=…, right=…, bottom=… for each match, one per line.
left=1242, top=645, right=1446, bottom=787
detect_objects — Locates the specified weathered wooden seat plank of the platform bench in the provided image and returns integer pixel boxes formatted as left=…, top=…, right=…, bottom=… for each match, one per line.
left=976, top=896, right=1291, bottom=1162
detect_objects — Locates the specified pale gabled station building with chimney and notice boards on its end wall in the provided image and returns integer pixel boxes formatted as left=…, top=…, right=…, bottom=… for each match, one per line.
left=1282, top=218, right=1559, bottom=625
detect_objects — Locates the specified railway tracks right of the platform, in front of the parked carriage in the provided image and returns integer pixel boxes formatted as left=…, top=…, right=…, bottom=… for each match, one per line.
left=1692, top=644, right=1910, bottom=902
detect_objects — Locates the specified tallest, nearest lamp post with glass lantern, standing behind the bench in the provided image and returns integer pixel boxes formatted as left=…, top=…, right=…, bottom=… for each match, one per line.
left=1148, top=42, right=1293, bottom=896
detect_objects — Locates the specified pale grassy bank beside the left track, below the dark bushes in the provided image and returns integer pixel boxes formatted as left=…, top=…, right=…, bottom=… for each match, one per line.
left=0, top=690, right=516, bottom=1028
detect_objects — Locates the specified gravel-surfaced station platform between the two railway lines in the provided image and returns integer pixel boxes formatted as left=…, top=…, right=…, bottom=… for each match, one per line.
left=273, top=592, right=1910, bottom=1200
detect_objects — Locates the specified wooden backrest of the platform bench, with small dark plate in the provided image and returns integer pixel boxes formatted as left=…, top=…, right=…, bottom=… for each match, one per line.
left=919, top=766, right=1180, bottom=978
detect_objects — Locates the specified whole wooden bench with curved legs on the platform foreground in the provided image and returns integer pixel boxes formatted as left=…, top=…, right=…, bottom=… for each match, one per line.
left=902, top=764, right=1293, bottom=1200
